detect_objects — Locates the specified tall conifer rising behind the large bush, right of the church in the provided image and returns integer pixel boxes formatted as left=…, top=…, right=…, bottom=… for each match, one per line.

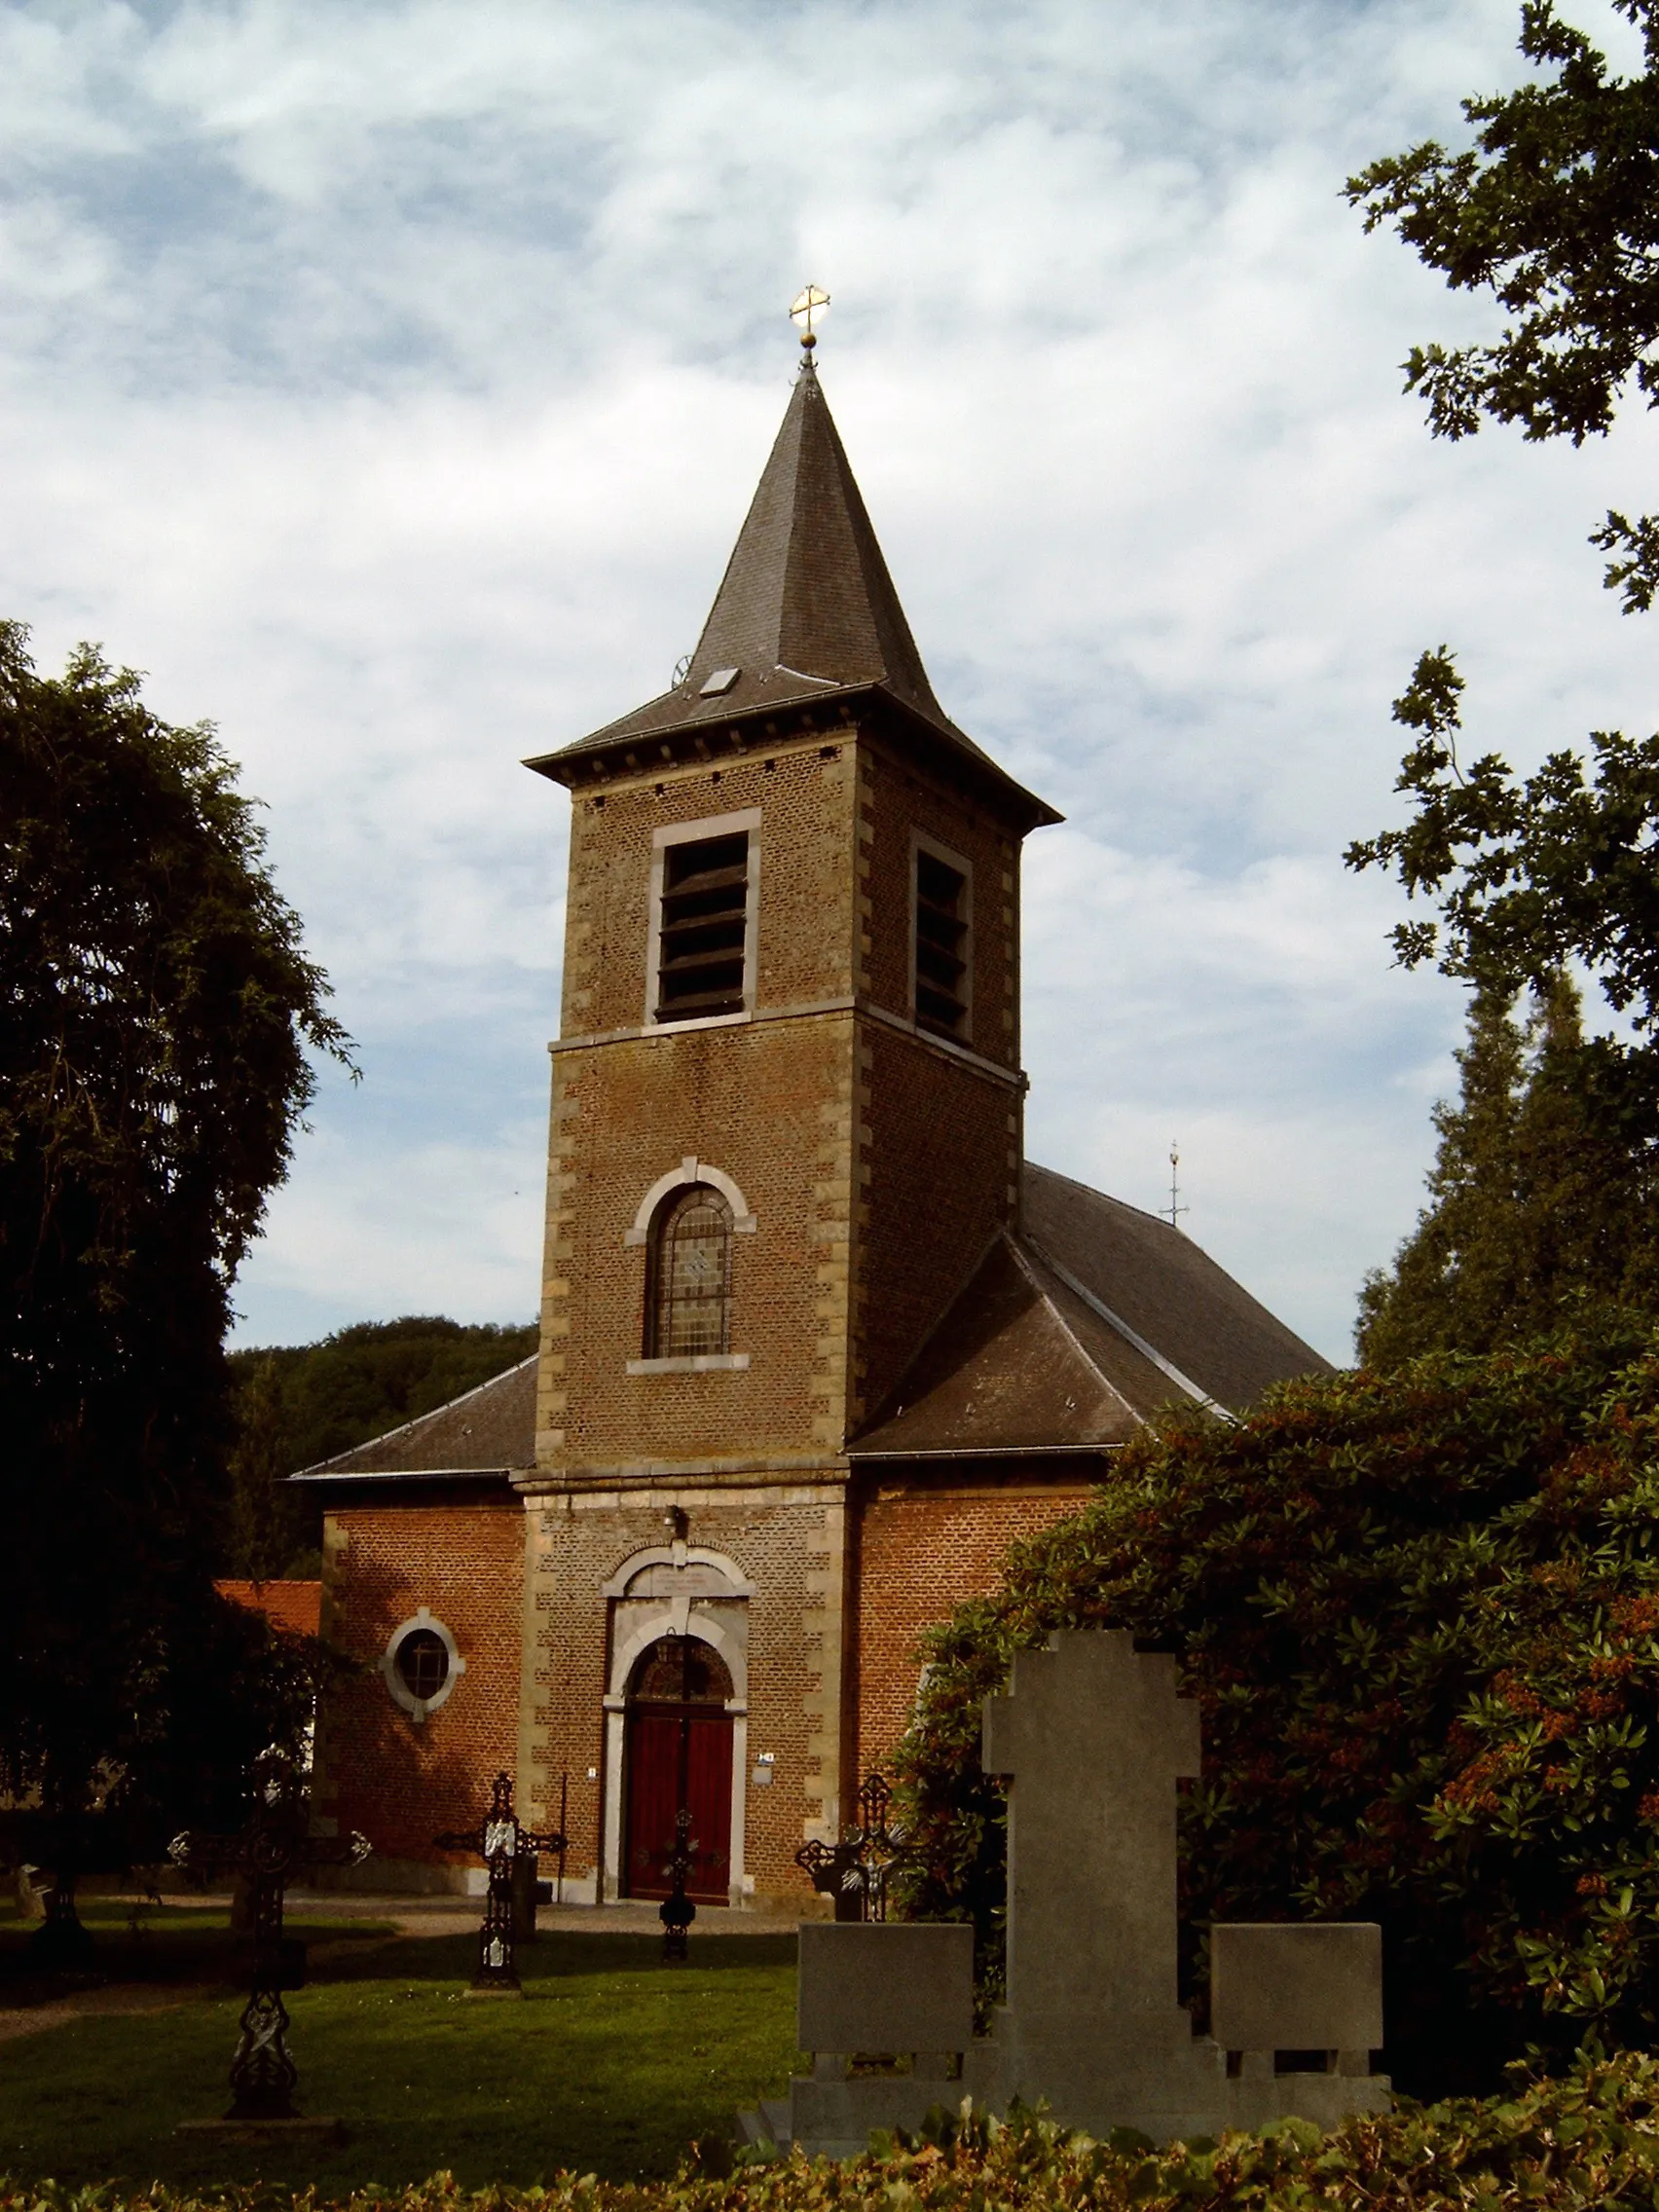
left=1358, top=976, right=1659, bottom=1367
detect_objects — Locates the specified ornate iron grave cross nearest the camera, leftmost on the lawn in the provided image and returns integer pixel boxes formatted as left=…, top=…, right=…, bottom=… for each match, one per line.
left=168, top=1751, right=372, bottom=2120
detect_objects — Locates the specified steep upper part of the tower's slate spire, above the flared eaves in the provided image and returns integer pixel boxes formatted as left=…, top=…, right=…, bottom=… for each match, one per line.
left=685, top=354, right=944, bottom=721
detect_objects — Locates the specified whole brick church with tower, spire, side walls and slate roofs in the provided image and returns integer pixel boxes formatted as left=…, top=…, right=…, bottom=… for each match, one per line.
left=296, top=336, right=1325, bottom=1904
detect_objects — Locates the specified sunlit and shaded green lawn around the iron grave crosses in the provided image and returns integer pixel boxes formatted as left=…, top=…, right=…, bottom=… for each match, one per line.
left=0, top=1906, right=794, bottom=2194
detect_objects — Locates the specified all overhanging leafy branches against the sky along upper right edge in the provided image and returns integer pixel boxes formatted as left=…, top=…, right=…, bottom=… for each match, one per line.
left=1347, top=0, right=1659, bottom=1161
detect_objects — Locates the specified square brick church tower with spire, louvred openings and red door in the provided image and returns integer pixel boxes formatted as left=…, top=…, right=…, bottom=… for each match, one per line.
left=515, top=315, right=1057, bottom=1902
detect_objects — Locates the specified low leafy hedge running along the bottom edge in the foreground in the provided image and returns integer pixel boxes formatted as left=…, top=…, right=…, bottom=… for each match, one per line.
left=0, top=2055, right=1659, bottom=2212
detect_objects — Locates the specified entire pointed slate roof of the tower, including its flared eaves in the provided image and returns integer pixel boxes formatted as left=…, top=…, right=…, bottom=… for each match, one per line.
left=527, top=360, right=1059, bottom=825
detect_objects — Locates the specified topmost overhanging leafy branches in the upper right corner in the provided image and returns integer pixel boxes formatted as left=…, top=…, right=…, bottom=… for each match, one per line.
left=1347, top=0, right=1659, bottom=612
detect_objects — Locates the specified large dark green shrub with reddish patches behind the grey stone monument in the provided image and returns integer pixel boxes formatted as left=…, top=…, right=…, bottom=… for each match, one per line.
left=896, top=1320, right=1659, bottom=2092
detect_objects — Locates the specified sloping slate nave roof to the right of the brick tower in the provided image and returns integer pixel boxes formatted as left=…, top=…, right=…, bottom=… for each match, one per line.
left=849, top=1163, right=1329, bottom=1460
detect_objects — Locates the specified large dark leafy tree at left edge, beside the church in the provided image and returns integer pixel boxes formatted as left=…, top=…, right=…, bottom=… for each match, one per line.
left=0, top=624, right=345, bottom=1840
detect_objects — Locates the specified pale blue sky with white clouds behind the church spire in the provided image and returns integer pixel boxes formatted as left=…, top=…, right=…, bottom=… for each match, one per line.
left=0, top=0, right=1659, bottom=1358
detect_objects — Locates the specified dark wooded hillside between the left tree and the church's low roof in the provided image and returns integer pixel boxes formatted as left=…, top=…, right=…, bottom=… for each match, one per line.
left=221, top=1314, right=537, bottom=1577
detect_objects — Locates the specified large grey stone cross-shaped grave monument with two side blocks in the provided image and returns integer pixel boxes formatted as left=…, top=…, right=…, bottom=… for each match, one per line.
left=760, top=1630, right=1389, bottom=2157
